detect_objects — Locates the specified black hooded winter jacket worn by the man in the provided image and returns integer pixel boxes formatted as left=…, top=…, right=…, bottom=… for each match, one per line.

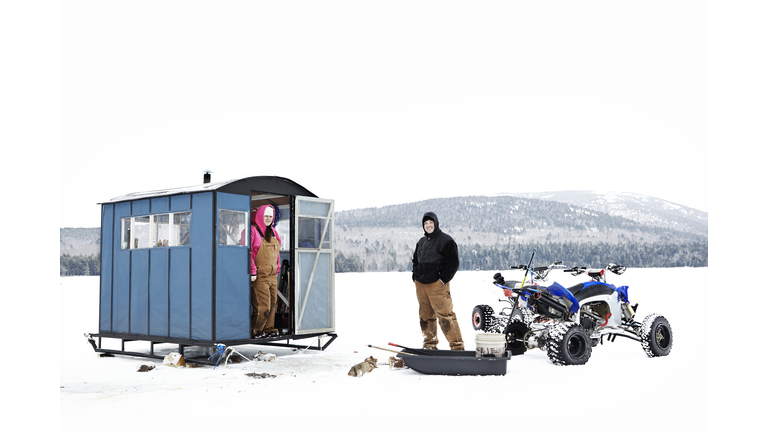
left=412, top=212, right=459, bottom=284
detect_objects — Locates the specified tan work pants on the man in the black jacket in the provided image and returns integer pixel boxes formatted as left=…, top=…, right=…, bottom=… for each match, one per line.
left=415, top=280, right=464, bottom=350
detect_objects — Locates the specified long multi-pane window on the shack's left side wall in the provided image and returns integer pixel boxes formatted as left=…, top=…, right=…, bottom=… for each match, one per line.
left=121, top=212, right=191, bottom=249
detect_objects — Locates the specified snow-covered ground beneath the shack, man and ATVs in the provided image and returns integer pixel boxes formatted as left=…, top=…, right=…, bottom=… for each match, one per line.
left=59, top=268, right=717, bottom=431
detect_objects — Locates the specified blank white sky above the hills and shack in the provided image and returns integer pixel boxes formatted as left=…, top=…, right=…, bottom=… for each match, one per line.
left=55, top=1, right=708, bottom=227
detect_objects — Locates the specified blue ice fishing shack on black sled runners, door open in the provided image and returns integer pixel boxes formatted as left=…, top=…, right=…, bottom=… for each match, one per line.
left=86, top=173, right=337, bottom=360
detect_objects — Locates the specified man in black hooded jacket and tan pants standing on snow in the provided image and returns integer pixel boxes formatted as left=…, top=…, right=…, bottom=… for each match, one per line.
left=412, top=212, right=464, bottom=350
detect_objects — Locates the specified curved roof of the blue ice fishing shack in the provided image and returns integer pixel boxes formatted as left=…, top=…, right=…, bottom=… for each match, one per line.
left=100, top=176, right=317, bottom=204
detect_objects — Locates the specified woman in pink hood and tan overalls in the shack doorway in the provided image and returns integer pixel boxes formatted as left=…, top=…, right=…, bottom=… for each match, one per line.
left=251, top=205, right=280, bottom=338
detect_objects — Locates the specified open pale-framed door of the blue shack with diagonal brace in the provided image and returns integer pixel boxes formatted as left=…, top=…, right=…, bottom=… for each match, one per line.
left=294, top=196, right=335, bottom=334
